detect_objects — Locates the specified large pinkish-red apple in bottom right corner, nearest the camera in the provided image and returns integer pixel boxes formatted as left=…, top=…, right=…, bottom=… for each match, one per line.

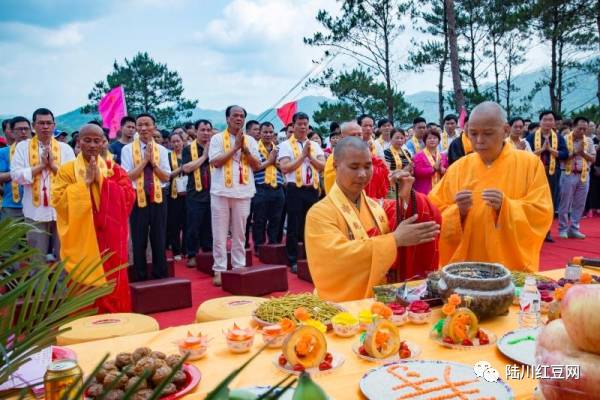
left=535, top=319, right=600, bottom=400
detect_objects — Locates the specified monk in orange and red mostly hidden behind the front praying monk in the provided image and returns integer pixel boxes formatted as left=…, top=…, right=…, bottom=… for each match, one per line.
left=323, top=121, right=390, bottom=199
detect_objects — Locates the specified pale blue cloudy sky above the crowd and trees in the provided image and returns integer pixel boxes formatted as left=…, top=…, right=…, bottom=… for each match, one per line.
left=0, top=0, right=545, bottom=115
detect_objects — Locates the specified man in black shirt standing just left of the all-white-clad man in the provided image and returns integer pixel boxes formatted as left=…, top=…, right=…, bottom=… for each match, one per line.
left=181, top=119, right=213, bottom=268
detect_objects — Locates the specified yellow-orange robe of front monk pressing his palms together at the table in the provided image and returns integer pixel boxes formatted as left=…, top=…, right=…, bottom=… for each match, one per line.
left=305, top=185, right=396, bottom=302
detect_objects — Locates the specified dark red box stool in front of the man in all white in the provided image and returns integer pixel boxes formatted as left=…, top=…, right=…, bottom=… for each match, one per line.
left=221, top=264, right=288, bottom=296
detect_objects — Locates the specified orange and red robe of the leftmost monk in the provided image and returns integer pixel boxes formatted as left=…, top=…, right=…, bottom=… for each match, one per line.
left=52, top=153, right=135, bottom=313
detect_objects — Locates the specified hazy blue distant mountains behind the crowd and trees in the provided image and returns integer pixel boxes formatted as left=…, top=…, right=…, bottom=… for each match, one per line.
left=31, top=65, right=596, bottom=132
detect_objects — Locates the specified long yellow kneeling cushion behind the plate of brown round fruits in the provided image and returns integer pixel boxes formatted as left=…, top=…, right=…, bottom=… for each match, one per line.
left=57, top=313, right=159, bottom=345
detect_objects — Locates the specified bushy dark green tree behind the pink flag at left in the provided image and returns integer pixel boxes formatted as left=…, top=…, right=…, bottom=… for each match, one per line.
left=84, top=52, right=198, bottom=128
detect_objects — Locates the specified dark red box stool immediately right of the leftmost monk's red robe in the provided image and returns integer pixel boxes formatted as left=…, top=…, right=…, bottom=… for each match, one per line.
left=129, top=278, right=192, bottom=314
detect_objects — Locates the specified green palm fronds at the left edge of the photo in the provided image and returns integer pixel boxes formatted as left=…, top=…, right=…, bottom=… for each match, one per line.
left=0, top=219, right=112, bottom=382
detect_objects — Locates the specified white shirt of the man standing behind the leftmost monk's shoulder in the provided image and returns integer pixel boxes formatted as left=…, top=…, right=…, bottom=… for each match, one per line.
left=10, top=139, right=75, bottom=222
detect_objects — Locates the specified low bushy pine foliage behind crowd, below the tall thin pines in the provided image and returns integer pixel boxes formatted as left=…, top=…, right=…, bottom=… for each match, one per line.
left=313, top=68, right=422, bottom=124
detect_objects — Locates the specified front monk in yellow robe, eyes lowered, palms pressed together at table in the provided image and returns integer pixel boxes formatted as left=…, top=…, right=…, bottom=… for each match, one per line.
left=305, top=137, right=439, bottom=301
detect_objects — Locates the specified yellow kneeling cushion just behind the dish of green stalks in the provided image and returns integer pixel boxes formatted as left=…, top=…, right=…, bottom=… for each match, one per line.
left=196, top=296, right=267, bottom=322
